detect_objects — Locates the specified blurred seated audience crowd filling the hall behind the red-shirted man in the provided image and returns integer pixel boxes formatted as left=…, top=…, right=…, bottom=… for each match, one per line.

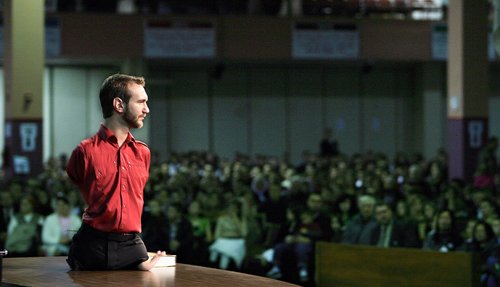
left=0, top=144, right=500, bottom=286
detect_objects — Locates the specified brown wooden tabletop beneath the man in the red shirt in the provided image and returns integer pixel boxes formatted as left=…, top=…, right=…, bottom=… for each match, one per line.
left=2, top=257, right=297, bottom=287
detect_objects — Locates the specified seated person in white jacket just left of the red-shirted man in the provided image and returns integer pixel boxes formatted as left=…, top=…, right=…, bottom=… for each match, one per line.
left=42, top=197, right=82, bottom=256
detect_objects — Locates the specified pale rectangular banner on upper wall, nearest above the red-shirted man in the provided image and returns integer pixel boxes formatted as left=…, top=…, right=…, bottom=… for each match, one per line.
left=144, top=20, right=216, bottom=58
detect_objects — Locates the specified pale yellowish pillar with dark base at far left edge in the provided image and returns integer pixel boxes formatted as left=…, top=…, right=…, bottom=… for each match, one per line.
left=3, top=0, right=45, bottom=176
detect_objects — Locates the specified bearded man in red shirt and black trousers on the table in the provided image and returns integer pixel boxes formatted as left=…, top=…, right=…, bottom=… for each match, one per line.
left=66, top=74, right=164, bottom=270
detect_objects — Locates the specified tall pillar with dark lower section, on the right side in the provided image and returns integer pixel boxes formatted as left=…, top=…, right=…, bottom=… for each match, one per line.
left=447, top=0, right=489, bottom=181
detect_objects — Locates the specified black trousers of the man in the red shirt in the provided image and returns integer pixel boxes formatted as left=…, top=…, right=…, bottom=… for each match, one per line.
left=66, top=224, right=148, bottom=270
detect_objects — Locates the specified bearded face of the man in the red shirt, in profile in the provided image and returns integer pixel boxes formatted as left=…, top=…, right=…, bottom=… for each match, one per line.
left=122, top=83, right=149, bottom=128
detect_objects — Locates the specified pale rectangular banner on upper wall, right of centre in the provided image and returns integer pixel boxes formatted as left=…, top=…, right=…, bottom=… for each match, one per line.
left=292, top=23, right=360, bottom=59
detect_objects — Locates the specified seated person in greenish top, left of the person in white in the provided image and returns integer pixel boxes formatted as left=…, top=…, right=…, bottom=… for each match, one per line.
left=5, top=195, right=43, bottom=257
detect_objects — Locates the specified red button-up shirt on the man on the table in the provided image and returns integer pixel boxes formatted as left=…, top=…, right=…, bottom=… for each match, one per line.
left=66, top=125, right=151, bottom=233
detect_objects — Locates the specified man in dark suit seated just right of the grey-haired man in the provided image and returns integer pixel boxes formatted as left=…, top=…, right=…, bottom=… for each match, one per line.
left=370, top=202, right=418, bottom=250
